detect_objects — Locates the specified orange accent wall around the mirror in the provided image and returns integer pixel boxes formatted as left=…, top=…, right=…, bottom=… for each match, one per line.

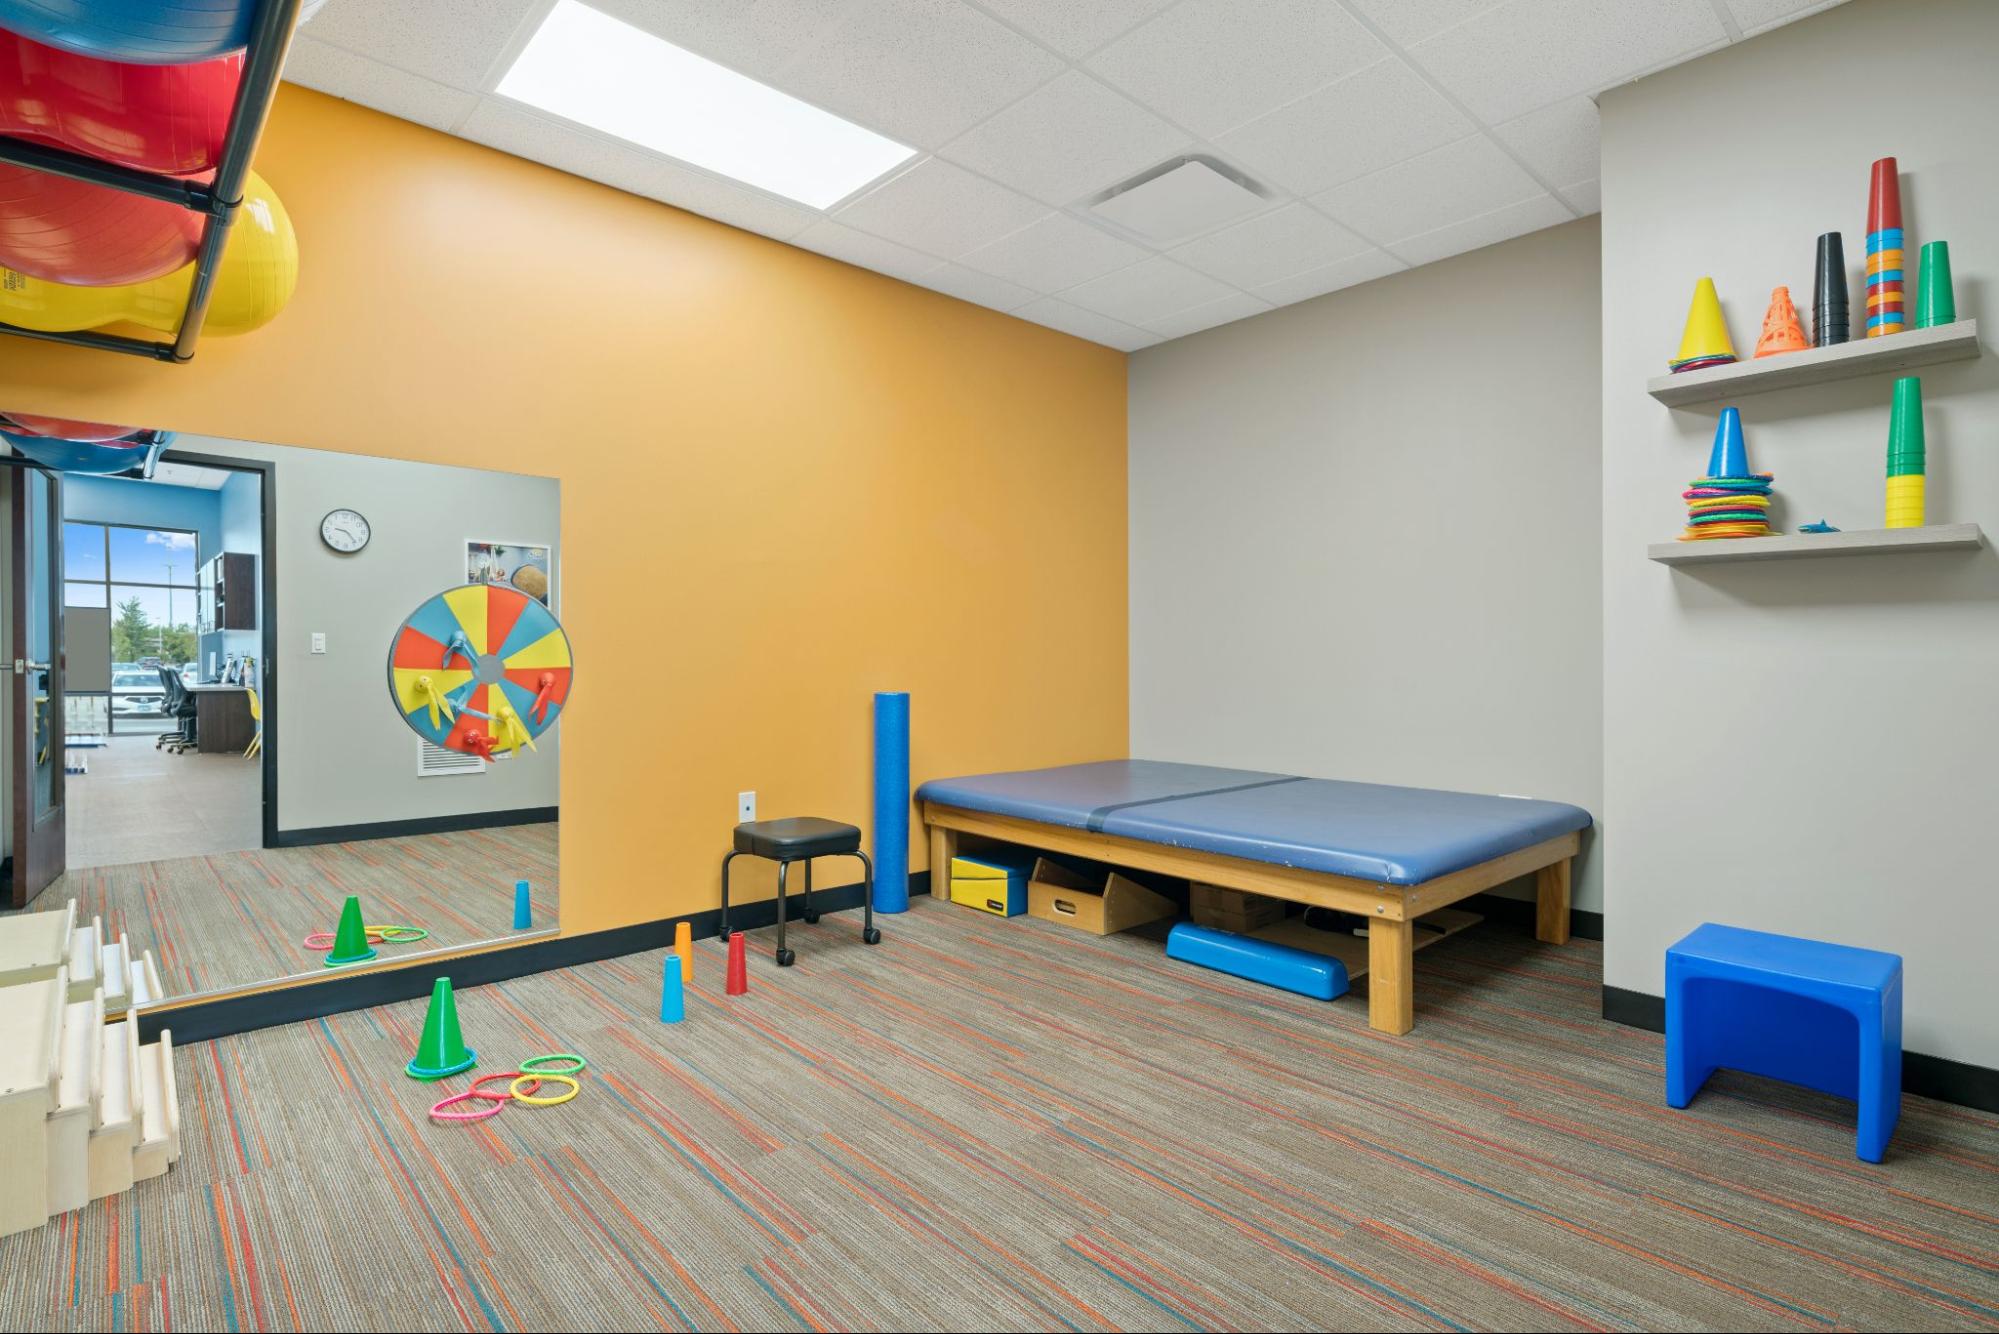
left=0, top=84, right=1127, bottom=934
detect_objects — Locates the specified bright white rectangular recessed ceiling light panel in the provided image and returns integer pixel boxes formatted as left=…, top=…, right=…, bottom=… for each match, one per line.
left=498, top=0, right=916, bottom=208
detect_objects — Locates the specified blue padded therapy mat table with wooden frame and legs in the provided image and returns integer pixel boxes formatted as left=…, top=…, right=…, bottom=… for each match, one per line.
left=916, top=760, right=1589, bottom=1032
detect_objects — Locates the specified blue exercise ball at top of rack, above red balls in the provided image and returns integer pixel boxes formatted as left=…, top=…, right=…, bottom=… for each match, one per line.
left=0, top=0, right=268, bottom=64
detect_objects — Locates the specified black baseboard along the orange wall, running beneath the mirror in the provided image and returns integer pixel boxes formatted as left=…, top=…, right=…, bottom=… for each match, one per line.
left=138, top=870, right=930, bottom=1046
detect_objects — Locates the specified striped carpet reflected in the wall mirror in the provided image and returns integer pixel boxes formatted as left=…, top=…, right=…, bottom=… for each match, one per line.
left=19, top=822, right=556, bottom=996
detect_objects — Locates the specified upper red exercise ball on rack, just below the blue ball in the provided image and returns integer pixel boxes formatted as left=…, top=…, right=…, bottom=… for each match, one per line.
left=0, top=28, right=244, bottom=176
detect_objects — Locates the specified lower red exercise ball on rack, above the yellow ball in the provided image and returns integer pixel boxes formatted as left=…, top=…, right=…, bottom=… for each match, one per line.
left=0, top=162, right=202, bottom=288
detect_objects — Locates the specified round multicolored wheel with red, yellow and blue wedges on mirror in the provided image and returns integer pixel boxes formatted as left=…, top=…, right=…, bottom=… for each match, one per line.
left=388, top=584, right=574, bottom=760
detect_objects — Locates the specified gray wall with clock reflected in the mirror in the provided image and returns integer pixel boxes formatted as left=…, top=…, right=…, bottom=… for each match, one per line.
left=176, top=436, right=562, bottom=830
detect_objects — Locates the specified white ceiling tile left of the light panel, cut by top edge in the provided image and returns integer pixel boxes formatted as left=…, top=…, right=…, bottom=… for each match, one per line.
left=289, top=0, right=544, bottom=92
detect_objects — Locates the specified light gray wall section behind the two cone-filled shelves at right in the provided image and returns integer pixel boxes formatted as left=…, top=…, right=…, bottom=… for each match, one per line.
left=1601, top=0, right=1999, bottom=1066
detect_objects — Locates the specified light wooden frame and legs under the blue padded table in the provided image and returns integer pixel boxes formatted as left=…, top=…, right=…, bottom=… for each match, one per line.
left=922, top=802, right=1583, bottom=1034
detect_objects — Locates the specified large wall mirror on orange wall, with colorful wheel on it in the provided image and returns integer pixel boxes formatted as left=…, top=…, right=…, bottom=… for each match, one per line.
left=0, top=418, right=570, bottom=1002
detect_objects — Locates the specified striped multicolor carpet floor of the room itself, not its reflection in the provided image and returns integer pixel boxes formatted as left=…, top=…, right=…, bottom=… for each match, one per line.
left=0, top=900, right=1999, bottom=1330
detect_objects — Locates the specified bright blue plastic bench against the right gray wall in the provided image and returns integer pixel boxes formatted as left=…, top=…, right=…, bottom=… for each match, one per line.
left=1665, top=922, right=1901, bottom=1162
